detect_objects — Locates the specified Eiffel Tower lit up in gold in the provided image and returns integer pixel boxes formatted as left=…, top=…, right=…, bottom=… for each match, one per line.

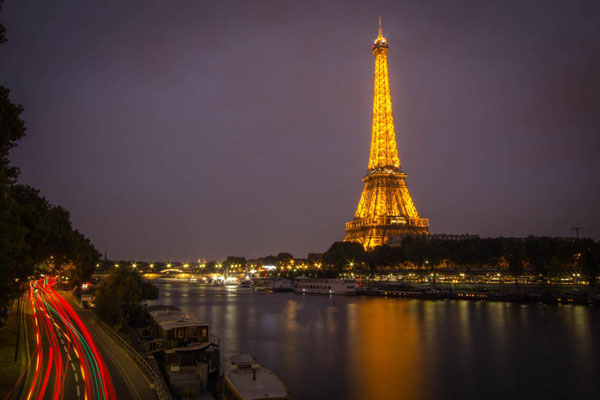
left=344, top=17, right=429, bottom=249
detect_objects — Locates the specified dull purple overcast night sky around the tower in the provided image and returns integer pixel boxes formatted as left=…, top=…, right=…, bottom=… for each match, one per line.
left=0, top=0, right=600, bottom=261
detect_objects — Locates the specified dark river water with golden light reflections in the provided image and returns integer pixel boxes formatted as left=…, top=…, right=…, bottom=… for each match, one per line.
left=146, top=283, right=600, bottom=399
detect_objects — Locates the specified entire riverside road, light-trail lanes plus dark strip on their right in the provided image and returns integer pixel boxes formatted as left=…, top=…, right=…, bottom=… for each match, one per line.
left=4, top=277, right=157, bottom=400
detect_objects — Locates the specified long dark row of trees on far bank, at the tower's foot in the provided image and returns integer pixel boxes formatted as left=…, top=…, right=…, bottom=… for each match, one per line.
left=322, top=236, right=600, bottom=279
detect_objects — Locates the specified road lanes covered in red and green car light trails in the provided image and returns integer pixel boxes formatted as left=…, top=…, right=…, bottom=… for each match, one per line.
left=13, top=278, right=117, bottom=400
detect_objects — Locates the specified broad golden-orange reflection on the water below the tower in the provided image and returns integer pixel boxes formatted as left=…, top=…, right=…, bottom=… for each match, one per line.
left=348, top=299, right=423, bottom=399
